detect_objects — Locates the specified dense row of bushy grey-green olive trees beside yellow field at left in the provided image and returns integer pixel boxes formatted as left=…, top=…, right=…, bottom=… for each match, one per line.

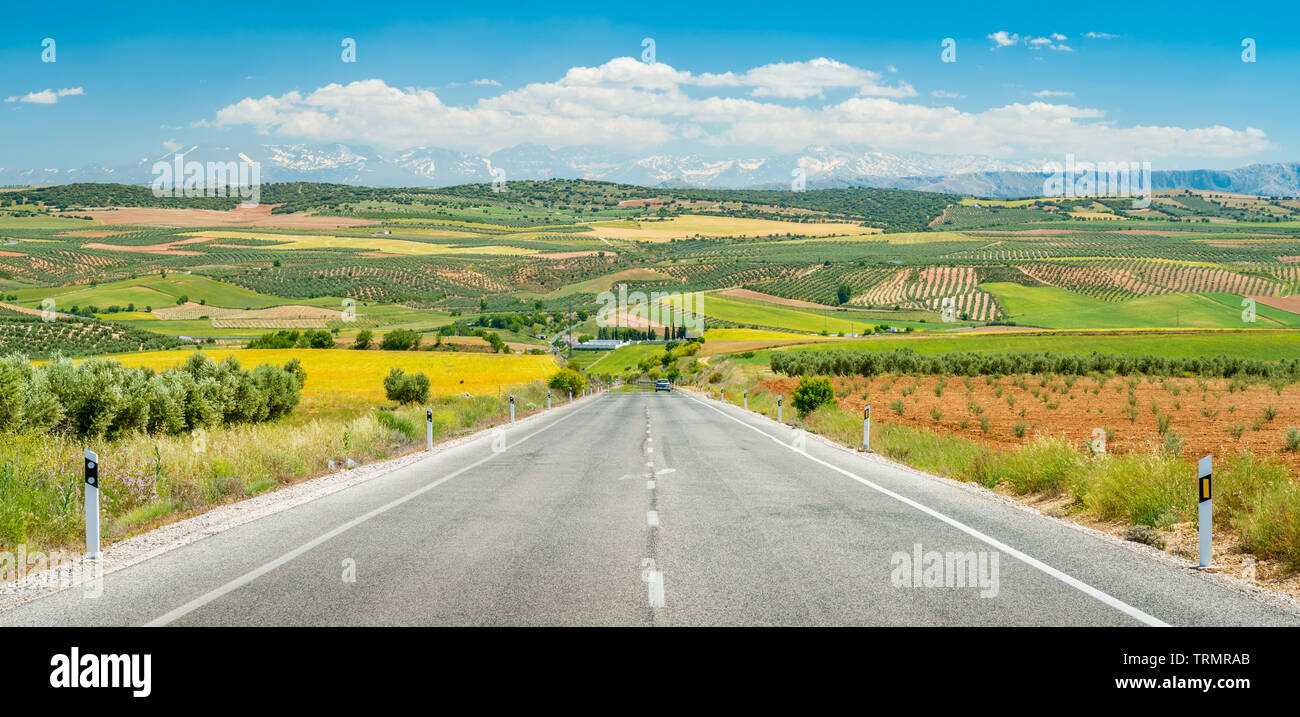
left=0, top=352, right=307, bottom=438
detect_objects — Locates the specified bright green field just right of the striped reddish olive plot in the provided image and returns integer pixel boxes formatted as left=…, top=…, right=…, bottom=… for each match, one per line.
left=980, top=282, right=1300, bottom=330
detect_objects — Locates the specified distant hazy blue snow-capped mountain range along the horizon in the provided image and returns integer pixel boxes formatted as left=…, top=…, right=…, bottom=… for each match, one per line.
left=0, top=144, right=1300, bottom=197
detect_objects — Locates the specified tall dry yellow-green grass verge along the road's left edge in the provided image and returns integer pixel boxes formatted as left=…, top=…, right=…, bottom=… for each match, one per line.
left=0, top=371, right=546, bottom=551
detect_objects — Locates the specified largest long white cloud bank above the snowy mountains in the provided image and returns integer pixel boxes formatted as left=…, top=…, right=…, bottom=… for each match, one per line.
left=207, top=57, right=1271, bottom=161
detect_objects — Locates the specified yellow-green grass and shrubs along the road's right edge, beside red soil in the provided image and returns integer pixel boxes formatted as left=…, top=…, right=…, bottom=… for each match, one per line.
left=699, top=366, right=1300, bottom=573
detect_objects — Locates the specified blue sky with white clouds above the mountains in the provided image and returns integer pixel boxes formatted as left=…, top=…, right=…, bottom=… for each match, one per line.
left=0, top=1, right=1300, bottom=169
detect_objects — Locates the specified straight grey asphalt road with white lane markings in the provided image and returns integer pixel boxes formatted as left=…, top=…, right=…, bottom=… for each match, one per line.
left=0, top=392, right=1300, bottom=626
